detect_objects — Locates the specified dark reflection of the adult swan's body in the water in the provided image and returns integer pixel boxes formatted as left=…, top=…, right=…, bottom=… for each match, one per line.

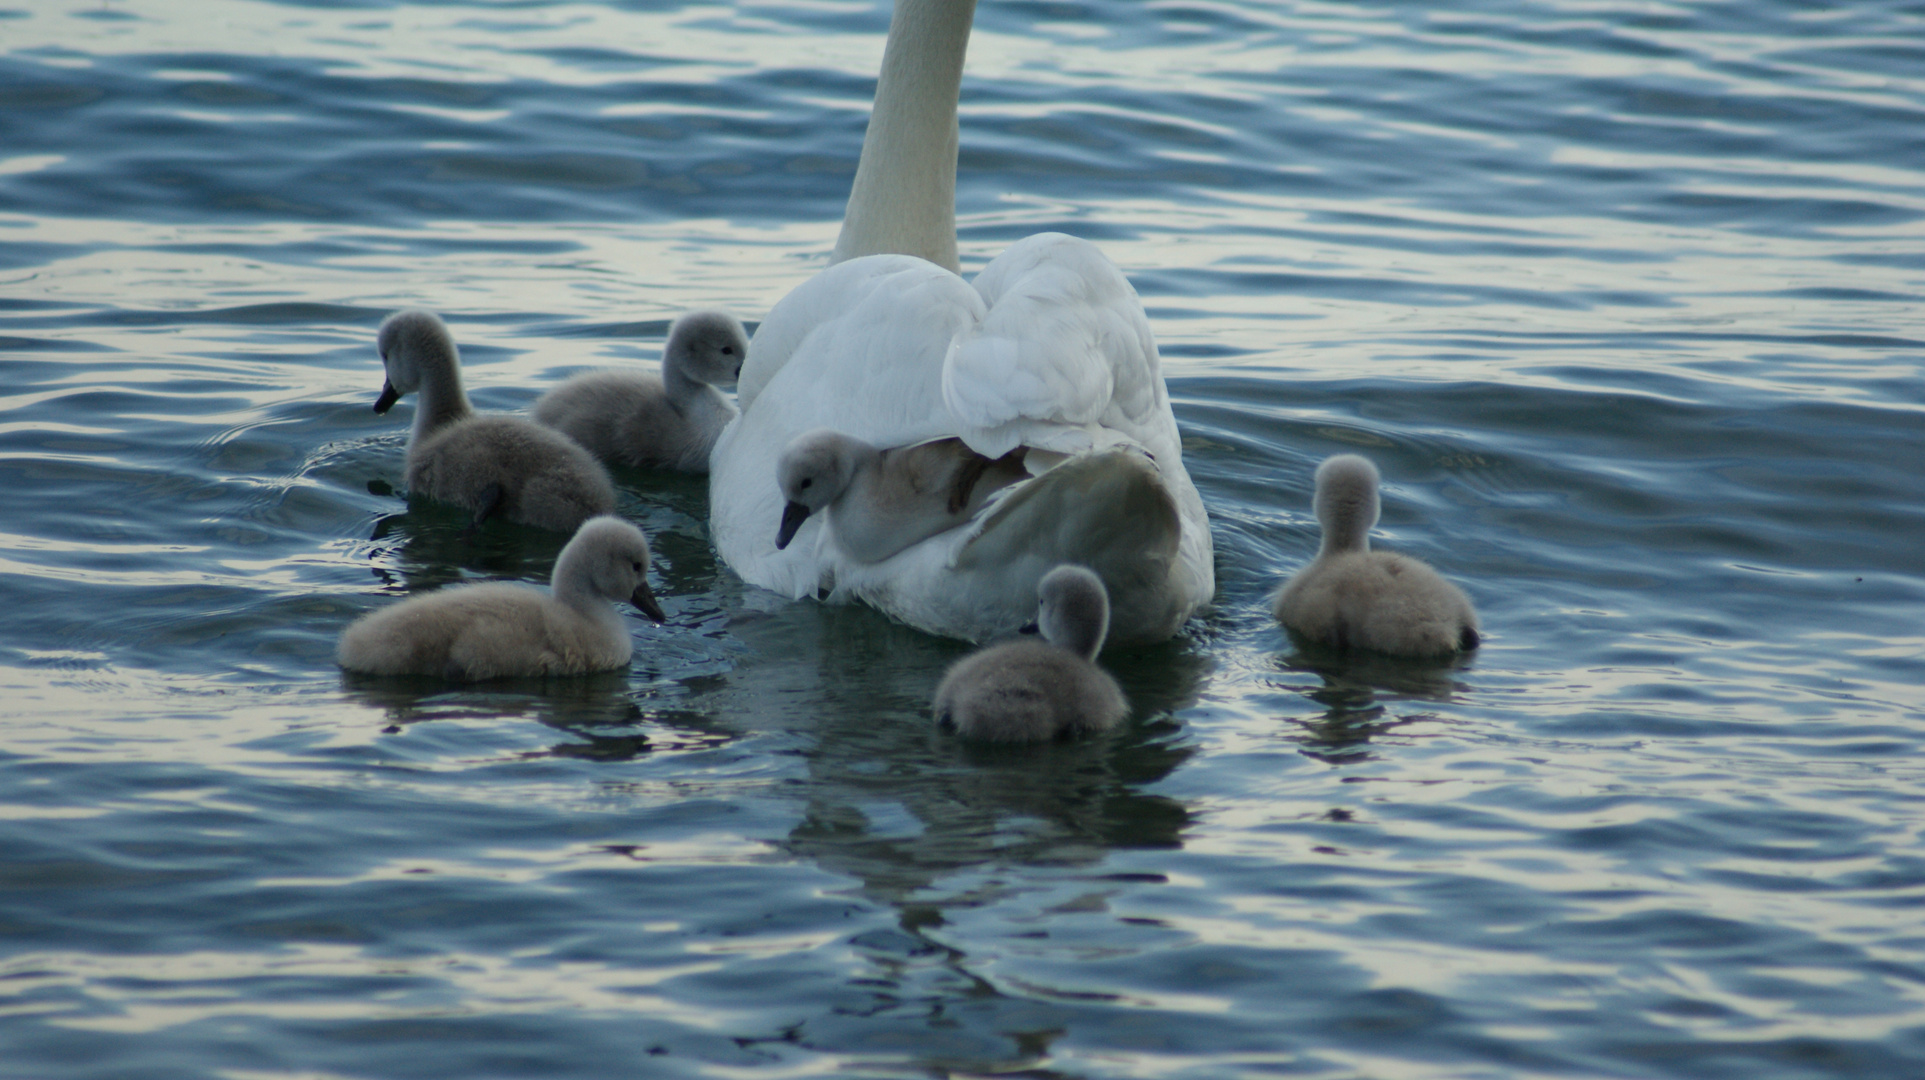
left=785, top=608, right=1211, bottom=900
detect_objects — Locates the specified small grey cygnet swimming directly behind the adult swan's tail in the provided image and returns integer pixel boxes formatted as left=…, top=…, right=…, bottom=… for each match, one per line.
left=936, top=566, right=1130, bottom=743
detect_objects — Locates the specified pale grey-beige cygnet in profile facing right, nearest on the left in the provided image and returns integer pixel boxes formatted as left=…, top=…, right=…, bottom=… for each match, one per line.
left=335, top=516, right=666, bottom=681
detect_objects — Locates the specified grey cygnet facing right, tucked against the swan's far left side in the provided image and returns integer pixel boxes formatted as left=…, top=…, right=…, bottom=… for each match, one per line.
left=533, top=312, right=749, bottom=472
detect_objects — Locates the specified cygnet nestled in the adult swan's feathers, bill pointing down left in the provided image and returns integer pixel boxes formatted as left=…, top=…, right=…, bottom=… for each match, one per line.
left=776, top=427, right=1030, bottom=562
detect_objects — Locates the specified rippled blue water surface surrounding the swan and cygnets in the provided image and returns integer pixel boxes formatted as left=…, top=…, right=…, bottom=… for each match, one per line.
left=0, top=0, right=1925, bottom=1080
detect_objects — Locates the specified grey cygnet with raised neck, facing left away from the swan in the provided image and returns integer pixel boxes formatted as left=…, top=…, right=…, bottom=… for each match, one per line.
left=373, top=312, right=614, bottom=533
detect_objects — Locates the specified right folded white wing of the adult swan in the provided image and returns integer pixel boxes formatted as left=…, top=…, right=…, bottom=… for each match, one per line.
left=943, top=233, right=1178, bottom=456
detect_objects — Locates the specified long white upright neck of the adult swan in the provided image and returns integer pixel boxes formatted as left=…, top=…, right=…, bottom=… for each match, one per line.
left=830, top=0, right=976, bottom=270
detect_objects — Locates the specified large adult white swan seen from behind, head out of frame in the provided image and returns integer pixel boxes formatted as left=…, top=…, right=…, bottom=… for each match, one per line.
left=708, top=0, right=1215, bottom=641
